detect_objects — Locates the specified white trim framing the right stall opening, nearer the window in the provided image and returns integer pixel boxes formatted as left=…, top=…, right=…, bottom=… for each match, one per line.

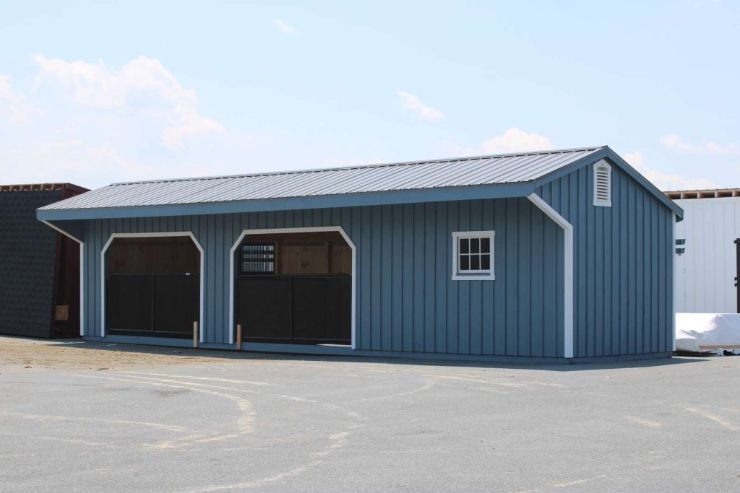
left=229, top=226, right=357, bottom=349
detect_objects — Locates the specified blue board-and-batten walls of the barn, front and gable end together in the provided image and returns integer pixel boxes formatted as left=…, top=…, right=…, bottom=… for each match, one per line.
left=72, top=160, right=673, bottom=358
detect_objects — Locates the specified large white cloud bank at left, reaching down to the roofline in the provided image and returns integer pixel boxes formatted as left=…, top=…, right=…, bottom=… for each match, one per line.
left=0, top=56, right=280, bottom=188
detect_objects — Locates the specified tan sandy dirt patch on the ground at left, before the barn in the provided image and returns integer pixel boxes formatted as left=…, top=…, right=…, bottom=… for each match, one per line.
left=0, top=337, right=238, bottom=371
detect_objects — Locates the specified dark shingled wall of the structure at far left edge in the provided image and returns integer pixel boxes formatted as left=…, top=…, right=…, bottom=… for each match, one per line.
left=0, top=190, right=62, bottom=337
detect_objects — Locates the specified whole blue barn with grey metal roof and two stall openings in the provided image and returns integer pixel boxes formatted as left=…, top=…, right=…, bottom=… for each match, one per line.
left=37, top=147, right=682, bottom=361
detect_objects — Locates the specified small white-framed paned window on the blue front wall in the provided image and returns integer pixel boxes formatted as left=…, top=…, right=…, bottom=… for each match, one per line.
left=452, top=231, right=495, bottom=281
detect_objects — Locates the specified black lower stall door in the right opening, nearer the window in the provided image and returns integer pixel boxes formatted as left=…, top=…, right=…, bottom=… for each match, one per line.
left=236, top=274, right=352, bottom=344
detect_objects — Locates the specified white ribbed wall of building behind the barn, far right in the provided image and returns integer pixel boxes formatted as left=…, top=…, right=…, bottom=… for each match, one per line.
left=676, top=197, right=740, bottom=313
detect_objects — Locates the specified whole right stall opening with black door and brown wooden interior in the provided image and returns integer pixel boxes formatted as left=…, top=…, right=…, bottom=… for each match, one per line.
left=234, top=231, right=352, bottom=345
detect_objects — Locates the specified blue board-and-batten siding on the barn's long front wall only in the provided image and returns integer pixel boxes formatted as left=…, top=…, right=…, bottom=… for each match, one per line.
left=85, top=198, right=563, bottom=358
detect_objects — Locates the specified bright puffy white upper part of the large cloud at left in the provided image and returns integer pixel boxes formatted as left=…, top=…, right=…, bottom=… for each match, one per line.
left=34, top=55, right=224, bottom=149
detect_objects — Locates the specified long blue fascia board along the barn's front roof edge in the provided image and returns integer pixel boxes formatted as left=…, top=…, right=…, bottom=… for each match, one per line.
left=36, top=182, right=535, bottom=221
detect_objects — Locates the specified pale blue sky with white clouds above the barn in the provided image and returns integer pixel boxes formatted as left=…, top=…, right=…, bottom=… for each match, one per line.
left=0, top=0, right=740, bottom=190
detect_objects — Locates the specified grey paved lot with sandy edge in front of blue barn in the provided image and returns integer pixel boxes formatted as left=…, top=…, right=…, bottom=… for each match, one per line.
left=0, top=337, right=740, bottom=492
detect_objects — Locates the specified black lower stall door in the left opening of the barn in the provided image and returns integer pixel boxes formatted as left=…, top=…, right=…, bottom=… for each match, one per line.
left=106, top=274, right=200, bottom=338
